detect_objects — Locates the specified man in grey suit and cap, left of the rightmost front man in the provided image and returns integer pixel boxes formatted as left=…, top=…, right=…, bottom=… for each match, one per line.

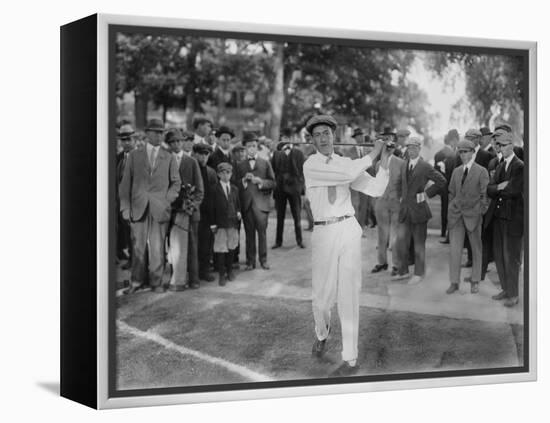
left=447, top=139, right=489, bottom=294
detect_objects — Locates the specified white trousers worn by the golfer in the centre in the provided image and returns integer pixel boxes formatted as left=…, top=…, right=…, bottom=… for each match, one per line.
left=311, top=217, right=362, bottom=361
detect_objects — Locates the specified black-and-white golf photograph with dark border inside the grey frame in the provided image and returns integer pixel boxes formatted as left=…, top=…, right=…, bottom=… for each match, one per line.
left=108, top=19, right=530, bottom=397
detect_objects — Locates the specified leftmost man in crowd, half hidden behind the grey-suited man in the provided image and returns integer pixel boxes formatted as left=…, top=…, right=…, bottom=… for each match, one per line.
left=116, top=124, right=136, bottom=269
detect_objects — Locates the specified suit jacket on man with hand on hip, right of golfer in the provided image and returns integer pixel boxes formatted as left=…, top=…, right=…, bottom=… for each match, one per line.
left=399, top=157, right=447, bottom=223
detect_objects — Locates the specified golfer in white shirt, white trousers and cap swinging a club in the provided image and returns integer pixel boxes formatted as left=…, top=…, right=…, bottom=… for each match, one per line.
left=304, top=115, right=389, bottom=376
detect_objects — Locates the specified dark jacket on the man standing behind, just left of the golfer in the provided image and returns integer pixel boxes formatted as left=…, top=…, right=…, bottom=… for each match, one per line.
left=271, top=148, right=306, bottom=195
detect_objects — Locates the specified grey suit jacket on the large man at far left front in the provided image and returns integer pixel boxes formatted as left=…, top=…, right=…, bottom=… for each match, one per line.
left=119, top=148, right=181, bottom=222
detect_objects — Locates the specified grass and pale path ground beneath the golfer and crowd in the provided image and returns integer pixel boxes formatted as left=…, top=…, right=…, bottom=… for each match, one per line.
left=116, top=200, right=523, bottom=390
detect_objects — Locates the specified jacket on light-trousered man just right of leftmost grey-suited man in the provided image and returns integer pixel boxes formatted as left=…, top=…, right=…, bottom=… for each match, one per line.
left=172, top=154, right=204, bottom=222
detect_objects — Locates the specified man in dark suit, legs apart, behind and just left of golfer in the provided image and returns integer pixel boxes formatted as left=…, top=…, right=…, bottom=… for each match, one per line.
left=271, top=140, right=306, bottom=248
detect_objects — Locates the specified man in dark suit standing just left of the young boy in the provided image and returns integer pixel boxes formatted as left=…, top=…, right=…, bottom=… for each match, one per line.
left=193, top=143, right=218, bottom=282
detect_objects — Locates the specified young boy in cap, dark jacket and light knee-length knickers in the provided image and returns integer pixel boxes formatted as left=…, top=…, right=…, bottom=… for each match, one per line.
left=209, top=162, right=241, bottom=286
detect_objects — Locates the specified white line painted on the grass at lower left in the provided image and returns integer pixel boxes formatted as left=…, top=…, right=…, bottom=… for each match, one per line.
left=117, top=320, right=274, bottom=382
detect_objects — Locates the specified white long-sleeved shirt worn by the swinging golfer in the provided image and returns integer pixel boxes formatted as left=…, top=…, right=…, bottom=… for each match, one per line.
left=304, top=152, right=389, bottom=221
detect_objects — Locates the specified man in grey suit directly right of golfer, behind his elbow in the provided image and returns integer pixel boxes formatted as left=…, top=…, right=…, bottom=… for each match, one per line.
left=371, top=142, right=408, bottom=278
